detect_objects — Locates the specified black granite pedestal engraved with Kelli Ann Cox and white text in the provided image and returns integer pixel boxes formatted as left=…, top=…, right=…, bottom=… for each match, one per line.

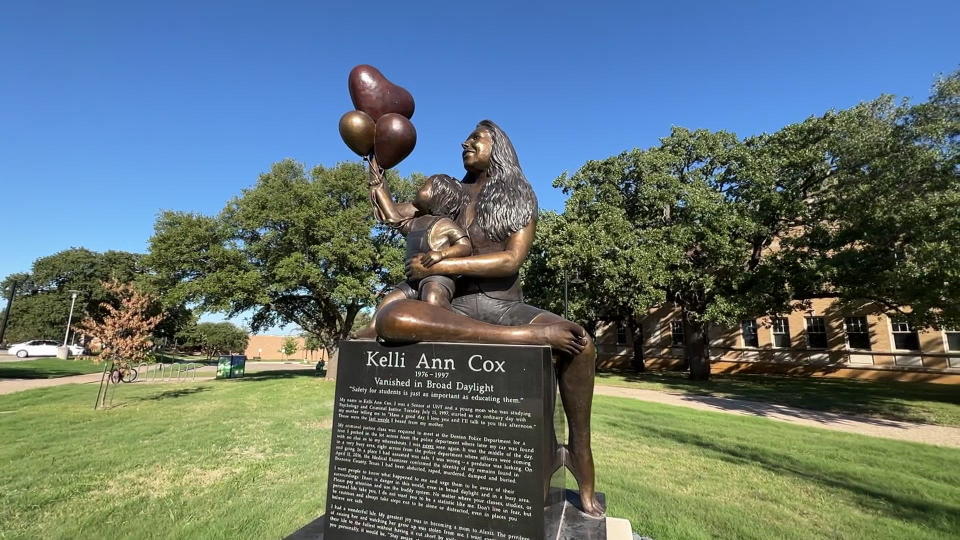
left=288, top=340, right=624, bottom=540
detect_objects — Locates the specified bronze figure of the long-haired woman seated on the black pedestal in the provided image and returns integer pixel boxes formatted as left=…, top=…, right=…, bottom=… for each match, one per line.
left=358, top=120, right=603, bottom=517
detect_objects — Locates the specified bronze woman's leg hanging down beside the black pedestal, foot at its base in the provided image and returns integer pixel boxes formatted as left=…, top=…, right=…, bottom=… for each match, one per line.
left=530, top=312, right=604, bottom=517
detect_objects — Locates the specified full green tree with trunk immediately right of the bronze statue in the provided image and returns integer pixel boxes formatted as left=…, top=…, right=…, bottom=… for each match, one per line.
left=555, top=128, right=797, bottom=378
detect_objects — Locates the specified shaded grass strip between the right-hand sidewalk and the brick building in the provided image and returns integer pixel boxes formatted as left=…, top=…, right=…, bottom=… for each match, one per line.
left=597, top=372, right=960, bottom=426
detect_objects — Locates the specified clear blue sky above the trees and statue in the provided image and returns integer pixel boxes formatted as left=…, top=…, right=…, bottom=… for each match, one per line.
left=0, top=0, right=960, bottom=330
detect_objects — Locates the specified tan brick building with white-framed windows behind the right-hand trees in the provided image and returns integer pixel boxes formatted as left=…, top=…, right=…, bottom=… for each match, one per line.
left=596, top=298, right=960, bottom=384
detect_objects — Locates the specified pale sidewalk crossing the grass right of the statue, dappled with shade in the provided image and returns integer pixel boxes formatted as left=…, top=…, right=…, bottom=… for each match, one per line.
left=595, top=385, right=960, bottom=448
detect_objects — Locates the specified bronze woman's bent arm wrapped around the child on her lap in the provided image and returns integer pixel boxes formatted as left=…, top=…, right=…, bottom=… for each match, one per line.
left=407, top=220, right=537, bottom=279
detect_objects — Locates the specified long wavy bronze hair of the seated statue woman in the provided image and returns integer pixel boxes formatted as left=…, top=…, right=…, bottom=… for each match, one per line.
left=477, top=120, right=537, bottom=242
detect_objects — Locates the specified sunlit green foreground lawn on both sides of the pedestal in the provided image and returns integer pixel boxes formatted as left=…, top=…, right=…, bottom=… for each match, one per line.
left=0, top=372, right=960, bottom=540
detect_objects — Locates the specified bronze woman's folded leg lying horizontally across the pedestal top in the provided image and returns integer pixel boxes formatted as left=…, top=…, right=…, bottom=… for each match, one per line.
left=374, top=300, right=588, bottom=355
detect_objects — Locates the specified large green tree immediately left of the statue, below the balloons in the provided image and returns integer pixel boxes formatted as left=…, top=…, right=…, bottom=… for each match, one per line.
left=149, top=160, right=412, bottom=356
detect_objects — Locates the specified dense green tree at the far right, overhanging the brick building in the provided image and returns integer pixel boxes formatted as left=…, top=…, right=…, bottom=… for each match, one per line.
left=772, top=71, right=960, bottom=326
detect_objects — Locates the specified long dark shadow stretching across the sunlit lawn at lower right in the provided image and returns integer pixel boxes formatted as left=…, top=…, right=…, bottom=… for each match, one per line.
left=644, top=426, right=960, bottom=535
